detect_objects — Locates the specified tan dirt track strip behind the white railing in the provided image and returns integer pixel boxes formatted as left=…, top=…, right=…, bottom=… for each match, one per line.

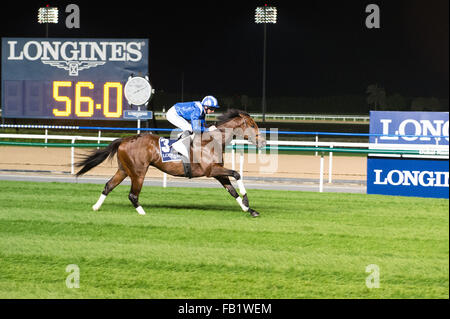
left=0, top=146, right=367, bottom=181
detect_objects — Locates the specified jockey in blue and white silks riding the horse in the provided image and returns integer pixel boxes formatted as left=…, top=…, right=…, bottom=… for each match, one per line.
left=166, top=95, right=219, bottom=158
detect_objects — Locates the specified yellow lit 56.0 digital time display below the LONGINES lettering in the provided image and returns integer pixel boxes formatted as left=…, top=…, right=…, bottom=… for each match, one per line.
left=4, top=81, right=125, bottom=119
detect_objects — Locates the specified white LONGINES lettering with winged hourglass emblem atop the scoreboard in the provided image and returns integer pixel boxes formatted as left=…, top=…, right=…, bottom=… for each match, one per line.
left=8, top=41, right=145, bottom=76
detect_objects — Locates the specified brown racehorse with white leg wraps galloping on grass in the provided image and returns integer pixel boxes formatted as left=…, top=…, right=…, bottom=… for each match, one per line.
left=76, top=109, right=266, bottom=217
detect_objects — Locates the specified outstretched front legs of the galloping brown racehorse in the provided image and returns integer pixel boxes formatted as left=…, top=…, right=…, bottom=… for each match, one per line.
left=211, top=167, right=259, bottom=217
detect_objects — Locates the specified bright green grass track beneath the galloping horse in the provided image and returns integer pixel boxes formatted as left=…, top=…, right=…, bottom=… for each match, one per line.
left=0, top=181, right=449, bottom=299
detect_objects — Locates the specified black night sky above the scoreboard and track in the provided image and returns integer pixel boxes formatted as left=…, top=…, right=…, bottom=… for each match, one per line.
left=0, top=0, right=449, bottom=98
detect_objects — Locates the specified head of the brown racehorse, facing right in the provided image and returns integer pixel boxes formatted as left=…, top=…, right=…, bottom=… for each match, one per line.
left=218, top=109, right=267, bottom=148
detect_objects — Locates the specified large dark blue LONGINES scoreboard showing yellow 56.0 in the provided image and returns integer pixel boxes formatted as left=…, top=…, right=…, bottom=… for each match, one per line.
left=1, top=38, right=148, bottom=120
